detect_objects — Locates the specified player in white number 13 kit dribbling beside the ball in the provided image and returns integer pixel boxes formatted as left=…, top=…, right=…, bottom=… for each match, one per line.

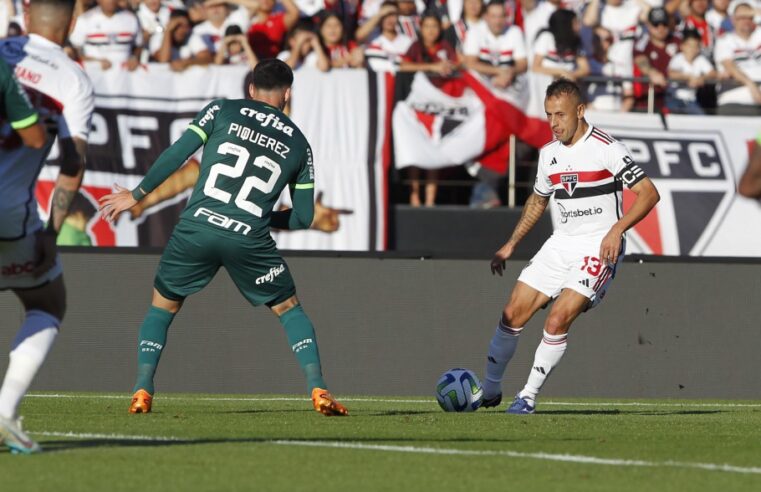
left=483, top=79, right=660, bottom=414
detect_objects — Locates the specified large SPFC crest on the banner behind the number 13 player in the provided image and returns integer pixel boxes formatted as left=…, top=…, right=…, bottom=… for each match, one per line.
left=611, top=128, right=735, bottom=256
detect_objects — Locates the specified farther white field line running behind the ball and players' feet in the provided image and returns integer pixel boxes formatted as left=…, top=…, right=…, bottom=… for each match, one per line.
left=26, top=393, right=761, bottom=408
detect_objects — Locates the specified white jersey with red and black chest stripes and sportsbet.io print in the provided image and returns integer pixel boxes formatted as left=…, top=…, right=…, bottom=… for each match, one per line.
left=534, top=125, right=645, bottom=236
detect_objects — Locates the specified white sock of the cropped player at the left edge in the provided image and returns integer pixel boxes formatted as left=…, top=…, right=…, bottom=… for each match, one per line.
left=0, top=326, right=58, bottom=420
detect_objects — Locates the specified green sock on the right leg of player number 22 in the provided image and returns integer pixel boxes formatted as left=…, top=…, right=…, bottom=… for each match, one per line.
left=280, top=306, right=327, bottom=392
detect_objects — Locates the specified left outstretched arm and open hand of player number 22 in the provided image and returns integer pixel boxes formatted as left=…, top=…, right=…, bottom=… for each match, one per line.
left=100, top=130, right=203, bottom=222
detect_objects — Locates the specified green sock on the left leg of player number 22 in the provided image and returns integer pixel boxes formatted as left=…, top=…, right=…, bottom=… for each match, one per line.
left=132, top=306, right=174, bottom=394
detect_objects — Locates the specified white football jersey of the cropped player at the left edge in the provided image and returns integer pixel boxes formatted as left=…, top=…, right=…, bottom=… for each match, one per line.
left=0, top=34, right=95, bottom=240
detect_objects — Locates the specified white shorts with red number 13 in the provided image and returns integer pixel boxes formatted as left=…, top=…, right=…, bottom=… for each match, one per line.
left=518, top=235, right=626, bottom=309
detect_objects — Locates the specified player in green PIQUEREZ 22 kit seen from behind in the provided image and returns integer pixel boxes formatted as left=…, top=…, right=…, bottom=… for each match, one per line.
left=101, top=59, right=349, bottom=416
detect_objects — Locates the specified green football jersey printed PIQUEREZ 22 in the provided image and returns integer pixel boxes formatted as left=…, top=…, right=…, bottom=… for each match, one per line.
left=180, top=99, right=314, bottom=239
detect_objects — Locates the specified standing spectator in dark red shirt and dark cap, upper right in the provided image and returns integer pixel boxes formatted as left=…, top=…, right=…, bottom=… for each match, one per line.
left=634, top=8, right=680, bottom=111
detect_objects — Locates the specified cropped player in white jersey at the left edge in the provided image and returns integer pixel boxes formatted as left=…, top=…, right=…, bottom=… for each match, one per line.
left=0, top=0, right=93, bottom=453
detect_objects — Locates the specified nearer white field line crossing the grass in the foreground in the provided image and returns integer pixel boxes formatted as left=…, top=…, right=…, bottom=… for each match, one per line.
left=23, top=431, right=761, bottom=475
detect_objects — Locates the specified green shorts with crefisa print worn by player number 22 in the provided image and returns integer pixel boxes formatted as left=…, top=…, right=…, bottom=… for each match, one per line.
left=153, top=221, right=296, bottom=306
